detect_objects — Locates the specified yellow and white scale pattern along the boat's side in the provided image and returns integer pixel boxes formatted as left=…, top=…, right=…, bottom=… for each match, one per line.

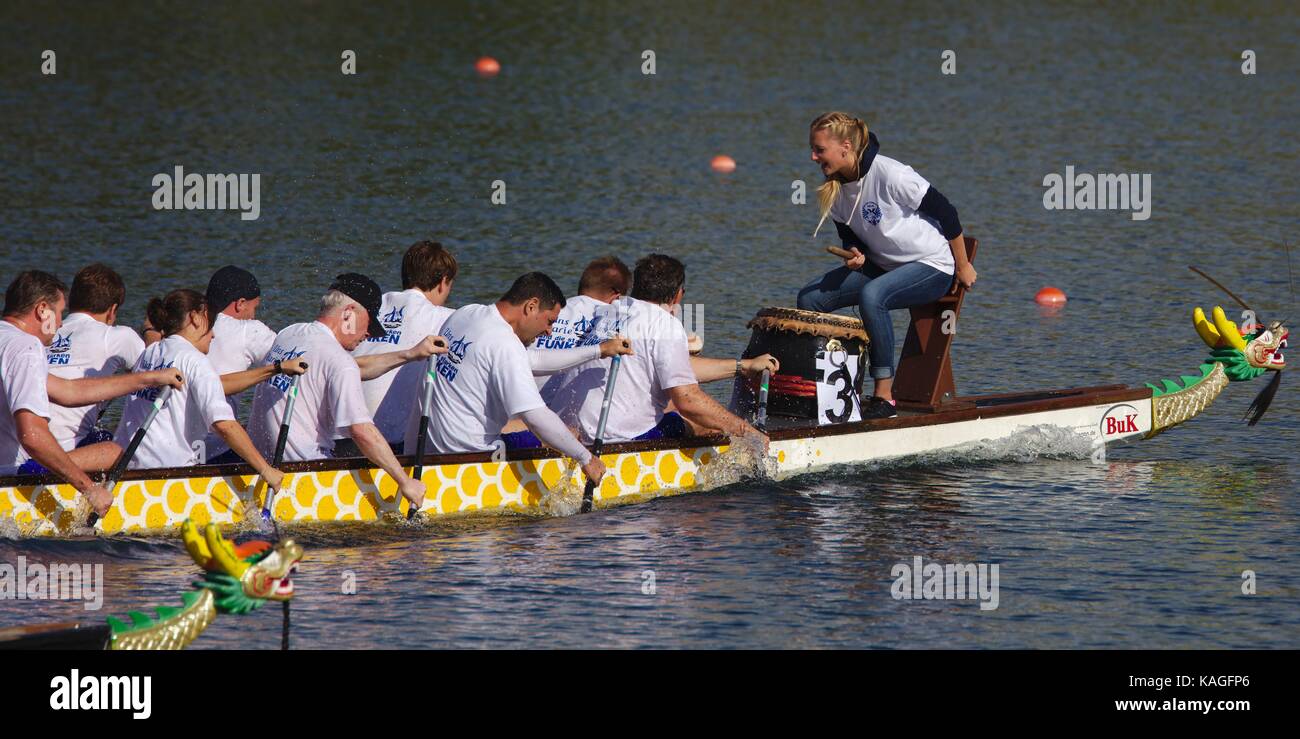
left=0, top=446, right=727, bottom=536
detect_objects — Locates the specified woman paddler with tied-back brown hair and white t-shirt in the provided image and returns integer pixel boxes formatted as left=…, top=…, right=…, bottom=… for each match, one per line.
left=90, top=290, right=283, bottom=490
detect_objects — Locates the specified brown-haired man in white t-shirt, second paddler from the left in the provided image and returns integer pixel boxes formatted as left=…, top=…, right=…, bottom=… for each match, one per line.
left=46, top=263, right=144, bottom=451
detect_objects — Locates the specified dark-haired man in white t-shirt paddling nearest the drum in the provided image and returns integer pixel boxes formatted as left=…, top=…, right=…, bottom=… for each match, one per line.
left=549, top=254, right=776, bottom=449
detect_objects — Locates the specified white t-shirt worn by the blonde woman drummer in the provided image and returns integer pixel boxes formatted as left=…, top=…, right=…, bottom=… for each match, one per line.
left=831, top=154, right=956, bottom=275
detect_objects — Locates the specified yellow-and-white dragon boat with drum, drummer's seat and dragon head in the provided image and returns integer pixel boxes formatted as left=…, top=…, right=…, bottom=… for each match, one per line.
left=0, top=248, right=1288, bottom=537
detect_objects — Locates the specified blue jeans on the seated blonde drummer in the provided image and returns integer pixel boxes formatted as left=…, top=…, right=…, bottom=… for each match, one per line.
left=798, top=262, right=953, bottom=380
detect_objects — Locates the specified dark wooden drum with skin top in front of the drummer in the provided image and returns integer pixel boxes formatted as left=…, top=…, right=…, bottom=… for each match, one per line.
left=731, top=308, right=871, bottom=422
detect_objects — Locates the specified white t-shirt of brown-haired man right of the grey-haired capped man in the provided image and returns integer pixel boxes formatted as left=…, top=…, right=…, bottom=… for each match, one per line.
left=352, top=288, right=452, bottom=444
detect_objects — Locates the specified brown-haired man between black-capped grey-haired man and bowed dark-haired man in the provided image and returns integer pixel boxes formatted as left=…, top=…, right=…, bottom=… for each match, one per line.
left=352, top=241, right=458, bottom=454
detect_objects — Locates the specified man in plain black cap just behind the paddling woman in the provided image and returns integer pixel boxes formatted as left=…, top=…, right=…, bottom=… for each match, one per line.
left=204, top=264, right=276, bottom=464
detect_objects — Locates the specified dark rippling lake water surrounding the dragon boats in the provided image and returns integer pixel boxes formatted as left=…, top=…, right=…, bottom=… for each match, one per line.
left=0, top=3, right=1300, bottom=648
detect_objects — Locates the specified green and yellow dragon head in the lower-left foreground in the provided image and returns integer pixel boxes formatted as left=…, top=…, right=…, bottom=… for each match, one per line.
left=181, top=520, right=303, bottom=614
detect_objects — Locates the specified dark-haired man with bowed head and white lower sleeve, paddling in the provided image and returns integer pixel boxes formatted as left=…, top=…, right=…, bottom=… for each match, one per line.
left=406, top=272, right=605, bottom=481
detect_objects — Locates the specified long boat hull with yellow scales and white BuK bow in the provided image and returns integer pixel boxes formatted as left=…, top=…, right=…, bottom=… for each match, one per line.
left=0, top=385, right=1159, bottom=536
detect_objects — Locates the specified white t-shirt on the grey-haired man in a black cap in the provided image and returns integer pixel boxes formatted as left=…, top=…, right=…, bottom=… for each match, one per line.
left=248, top=321, right=372, bottom=462
